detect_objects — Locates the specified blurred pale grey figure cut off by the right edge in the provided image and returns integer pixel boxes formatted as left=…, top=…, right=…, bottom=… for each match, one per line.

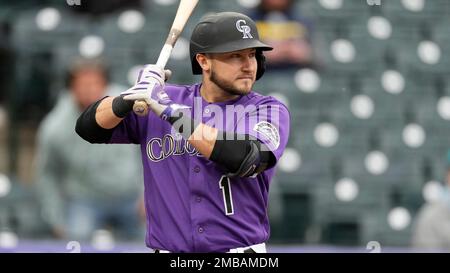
left=412, top=152, right=450, bottom=251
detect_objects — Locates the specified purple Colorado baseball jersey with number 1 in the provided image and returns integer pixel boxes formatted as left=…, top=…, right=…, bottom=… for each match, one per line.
left=110, top=84, right=289, bottom=252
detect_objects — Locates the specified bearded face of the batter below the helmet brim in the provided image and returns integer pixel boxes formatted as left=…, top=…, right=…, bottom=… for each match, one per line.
left=209, top=49, right=258, bottom=95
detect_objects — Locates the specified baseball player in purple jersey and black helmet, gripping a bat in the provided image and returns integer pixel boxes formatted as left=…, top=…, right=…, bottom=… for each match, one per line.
left=76, top=12, right=289, bottom=252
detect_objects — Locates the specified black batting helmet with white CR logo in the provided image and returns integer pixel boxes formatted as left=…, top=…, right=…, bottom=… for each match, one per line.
left=190, top=12, right=273, bottom=80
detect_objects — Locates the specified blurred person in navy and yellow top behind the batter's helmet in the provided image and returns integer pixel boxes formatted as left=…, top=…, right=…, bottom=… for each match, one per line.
left=250, top=0, right=314, bottom=69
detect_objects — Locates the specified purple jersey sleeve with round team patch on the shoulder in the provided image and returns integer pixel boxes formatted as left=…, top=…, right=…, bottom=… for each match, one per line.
left=236, top=99, right=290, bottom=162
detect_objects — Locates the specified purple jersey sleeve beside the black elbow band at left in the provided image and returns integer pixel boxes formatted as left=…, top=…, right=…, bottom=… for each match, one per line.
left=109, top=113, right=140, bottom=144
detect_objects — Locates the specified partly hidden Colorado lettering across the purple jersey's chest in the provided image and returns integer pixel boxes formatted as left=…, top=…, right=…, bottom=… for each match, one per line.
left=146, top=134, right=203, bottom=162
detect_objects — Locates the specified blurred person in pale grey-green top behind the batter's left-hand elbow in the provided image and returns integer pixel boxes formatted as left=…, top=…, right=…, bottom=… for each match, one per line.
left=36, top=57, right=145, bottom=240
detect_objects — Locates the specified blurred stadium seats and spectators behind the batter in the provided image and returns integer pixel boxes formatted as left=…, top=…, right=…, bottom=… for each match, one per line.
left=0, top=0, right=450, bottom=252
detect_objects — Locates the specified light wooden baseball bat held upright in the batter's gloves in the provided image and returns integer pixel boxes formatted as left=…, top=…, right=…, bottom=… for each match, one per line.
left=133, top=0, right=199, bottom=116
